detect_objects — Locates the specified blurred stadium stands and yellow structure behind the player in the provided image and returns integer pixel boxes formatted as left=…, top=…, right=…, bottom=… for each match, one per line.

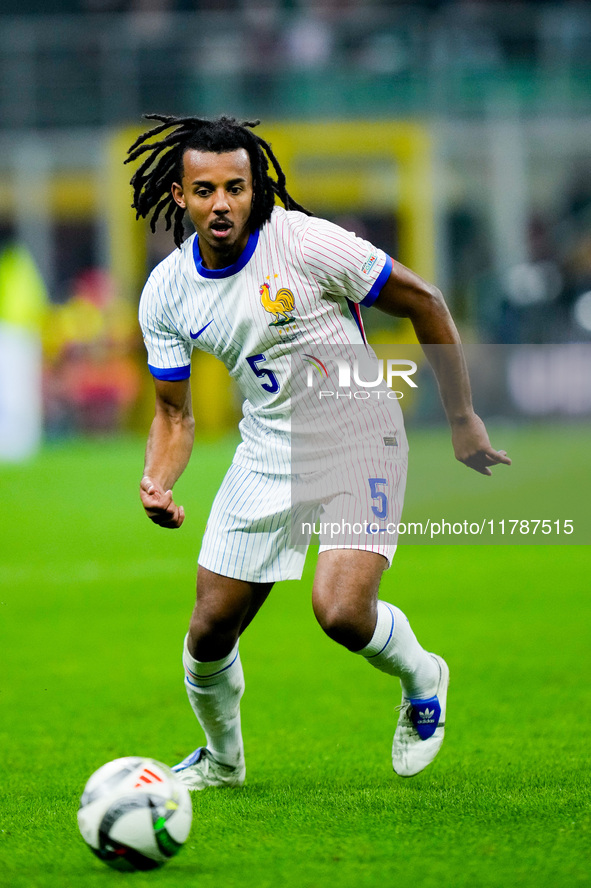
left=0, top=0, right=591, bottom=461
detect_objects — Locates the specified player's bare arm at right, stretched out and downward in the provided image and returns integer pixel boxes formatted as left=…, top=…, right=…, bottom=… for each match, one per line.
left=374, top=261, right=511, bottom=475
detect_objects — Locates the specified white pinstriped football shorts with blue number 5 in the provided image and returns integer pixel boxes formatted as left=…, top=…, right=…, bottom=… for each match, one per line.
left=198, top=454, right=408, bottom=583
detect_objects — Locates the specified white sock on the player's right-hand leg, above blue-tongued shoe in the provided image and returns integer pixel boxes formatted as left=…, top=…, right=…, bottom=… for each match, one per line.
left=358, top=601, right=439, bottom=700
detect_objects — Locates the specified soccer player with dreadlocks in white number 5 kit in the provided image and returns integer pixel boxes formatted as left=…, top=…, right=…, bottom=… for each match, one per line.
left=128, top=115, right=510, bottom=790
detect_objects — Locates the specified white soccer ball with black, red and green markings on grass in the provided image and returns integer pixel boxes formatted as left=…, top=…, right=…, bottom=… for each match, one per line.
left=78, top=756, right=193, bottom=871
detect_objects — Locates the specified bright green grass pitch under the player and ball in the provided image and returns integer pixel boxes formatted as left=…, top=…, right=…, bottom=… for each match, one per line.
left=0, top=427, right=591, bottom=888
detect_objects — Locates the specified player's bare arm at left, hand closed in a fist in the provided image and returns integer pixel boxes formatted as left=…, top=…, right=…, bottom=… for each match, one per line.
left=140, top=378, right=195, bottom=528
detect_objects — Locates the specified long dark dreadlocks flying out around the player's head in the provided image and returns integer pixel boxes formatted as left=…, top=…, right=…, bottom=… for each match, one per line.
left=125, top=114, right=312, bottom=247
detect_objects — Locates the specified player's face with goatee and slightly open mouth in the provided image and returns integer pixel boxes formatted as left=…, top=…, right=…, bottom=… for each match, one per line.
left=172, top=148, right=253, bottom=268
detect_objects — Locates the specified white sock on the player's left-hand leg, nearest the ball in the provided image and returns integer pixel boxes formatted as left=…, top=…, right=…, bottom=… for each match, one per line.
left=183, top=636, right=244, bottom=765
